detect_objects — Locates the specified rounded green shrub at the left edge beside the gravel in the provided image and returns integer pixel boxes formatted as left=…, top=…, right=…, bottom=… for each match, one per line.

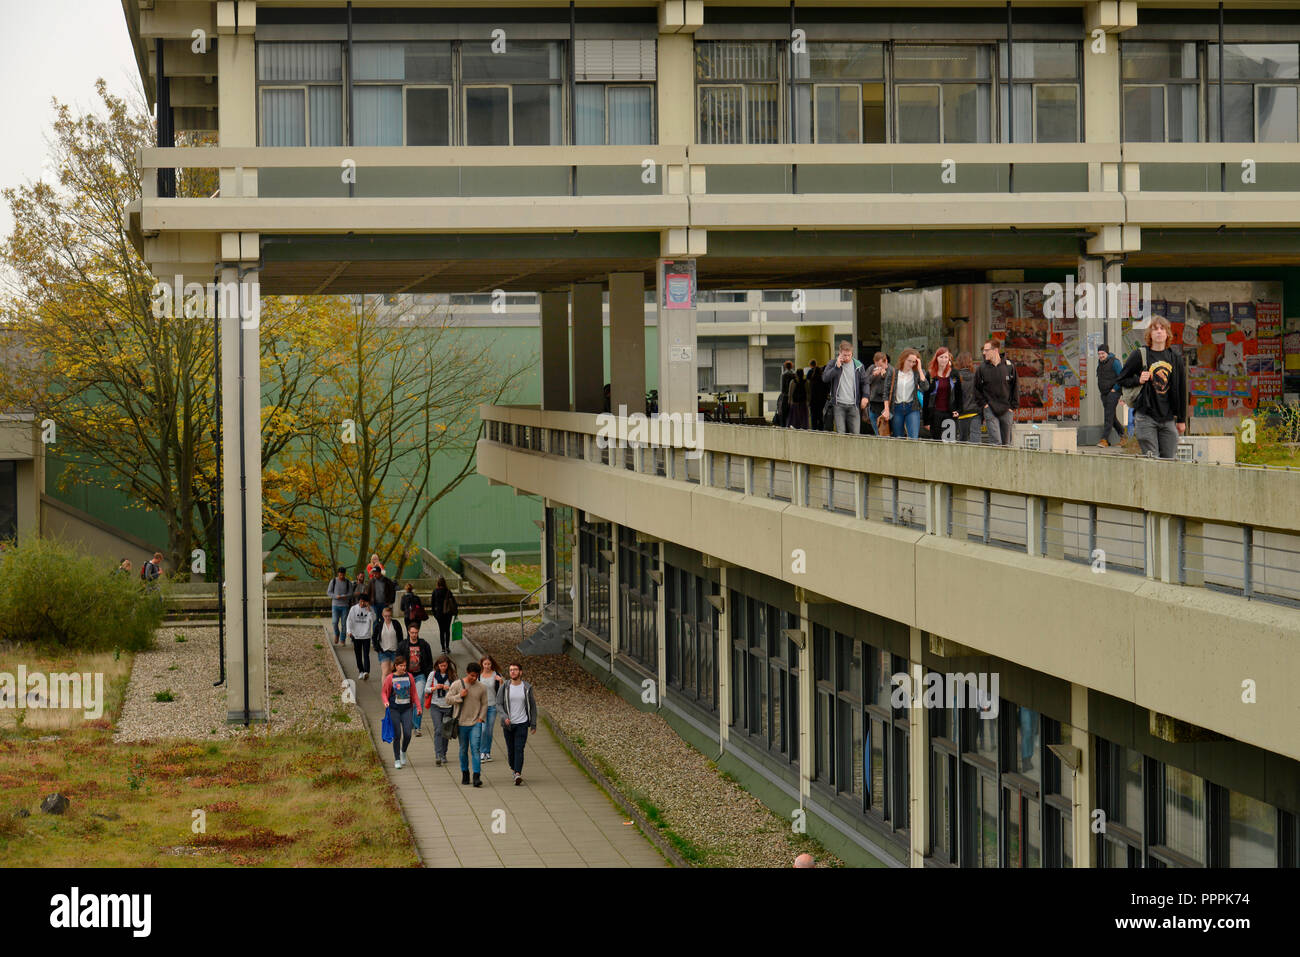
left=0, top=537, right=166, bottom=651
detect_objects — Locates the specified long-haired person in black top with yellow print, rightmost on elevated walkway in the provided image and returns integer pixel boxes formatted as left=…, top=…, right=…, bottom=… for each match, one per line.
left=1119, top=316, right=1187, bottom=459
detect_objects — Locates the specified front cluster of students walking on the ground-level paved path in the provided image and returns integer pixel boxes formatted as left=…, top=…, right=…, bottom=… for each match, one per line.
left=380, top=655, right=537, bottom=788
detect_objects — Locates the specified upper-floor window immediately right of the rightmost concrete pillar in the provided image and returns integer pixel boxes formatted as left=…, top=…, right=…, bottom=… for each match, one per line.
left=1119, top=42, right=1200, bottom=143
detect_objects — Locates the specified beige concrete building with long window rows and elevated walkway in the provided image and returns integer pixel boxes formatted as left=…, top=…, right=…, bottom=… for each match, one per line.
left=124, top=0, right=1300, bottom=867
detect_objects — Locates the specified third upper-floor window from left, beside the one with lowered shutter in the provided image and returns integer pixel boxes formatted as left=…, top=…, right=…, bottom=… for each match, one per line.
left=460, top=40, right=564, bottom=146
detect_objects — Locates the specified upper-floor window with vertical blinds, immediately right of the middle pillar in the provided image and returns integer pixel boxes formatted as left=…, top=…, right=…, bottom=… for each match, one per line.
left=696, top=40, right=781, bottom=143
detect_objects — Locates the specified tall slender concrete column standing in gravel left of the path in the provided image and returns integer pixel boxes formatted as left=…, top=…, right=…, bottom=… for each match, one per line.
left=218, top=257, right=267, bottom=723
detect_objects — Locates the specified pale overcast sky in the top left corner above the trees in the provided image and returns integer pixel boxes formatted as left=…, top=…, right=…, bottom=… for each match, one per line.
left=0, top=0, right=139, bottom=237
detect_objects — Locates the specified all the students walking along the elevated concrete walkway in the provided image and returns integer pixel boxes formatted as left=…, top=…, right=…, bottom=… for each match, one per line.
left=776, top=316, right=1187, bottom=459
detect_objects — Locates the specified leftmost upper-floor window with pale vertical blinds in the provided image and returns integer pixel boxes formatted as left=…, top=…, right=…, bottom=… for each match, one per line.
left=257, top=43, right=343, bottom=146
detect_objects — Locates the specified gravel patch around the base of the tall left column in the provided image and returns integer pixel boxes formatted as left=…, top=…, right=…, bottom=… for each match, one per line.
left=113, top=624, right=364, bottom=741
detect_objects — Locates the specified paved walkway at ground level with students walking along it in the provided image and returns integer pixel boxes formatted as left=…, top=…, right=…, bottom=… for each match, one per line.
left=325, top=623, right=667, bottom=867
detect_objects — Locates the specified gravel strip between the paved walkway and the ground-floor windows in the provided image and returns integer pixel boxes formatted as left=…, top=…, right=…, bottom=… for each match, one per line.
left=467, top=624, right=844, bottom=867
